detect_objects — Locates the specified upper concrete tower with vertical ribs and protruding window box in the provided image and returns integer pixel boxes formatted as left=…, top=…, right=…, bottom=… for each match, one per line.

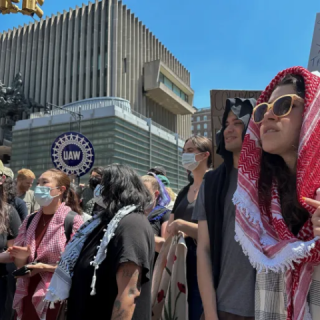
left=0, top=0, right=194, bottom=137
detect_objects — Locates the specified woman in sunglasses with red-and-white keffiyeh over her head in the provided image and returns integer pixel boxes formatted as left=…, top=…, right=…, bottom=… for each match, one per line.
left=234, top=67, right=320, bottom=320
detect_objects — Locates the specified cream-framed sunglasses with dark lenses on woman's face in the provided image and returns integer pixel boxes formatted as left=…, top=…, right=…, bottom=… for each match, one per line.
left=253, top=94, right=304, bottom=123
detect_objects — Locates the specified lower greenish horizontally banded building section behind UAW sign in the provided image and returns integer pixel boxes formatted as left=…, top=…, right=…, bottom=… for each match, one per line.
left=10, top=98, right=187, bottom=192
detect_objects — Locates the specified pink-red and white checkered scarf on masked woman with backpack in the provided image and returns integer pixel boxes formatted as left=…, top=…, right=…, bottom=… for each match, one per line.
left=13, top=203, right=83, bottom=320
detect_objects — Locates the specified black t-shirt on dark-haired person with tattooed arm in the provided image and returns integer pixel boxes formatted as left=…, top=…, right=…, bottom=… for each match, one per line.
left=67, top=213, right=154, bottom=320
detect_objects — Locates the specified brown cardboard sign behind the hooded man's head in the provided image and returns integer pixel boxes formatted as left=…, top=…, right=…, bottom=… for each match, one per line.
left=210, top=90, right=261, bottom=168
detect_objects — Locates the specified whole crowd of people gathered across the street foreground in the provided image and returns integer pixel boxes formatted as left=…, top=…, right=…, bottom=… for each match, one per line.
left=0, top=67, right=320, bottom=320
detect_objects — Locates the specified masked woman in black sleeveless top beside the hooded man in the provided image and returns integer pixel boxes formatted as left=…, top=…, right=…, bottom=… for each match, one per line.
left=166, top=136, right=212, bottom=320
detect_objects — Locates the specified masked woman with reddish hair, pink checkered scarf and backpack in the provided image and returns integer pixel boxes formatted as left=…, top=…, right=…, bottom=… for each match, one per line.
left=8, top=169, right=83, bottom=320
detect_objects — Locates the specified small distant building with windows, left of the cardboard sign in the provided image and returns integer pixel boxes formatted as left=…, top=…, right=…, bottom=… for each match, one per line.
left=191, top=108, right=212, bottom=139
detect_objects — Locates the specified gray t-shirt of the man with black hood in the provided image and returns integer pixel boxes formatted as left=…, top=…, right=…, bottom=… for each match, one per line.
left=192, top=168, right=256, bottom=317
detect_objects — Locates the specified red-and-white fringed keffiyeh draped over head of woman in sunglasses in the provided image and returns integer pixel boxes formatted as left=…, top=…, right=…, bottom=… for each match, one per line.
left=234, top=67, right=320, bottom=320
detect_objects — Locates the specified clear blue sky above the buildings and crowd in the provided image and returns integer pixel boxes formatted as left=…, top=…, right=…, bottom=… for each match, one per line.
left=0, top=0, right=320, bottom=108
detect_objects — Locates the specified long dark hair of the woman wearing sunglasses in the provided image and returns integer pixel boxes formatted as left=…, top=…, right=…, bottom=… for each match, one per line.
left=258, top=74, right=309, bottom=234
